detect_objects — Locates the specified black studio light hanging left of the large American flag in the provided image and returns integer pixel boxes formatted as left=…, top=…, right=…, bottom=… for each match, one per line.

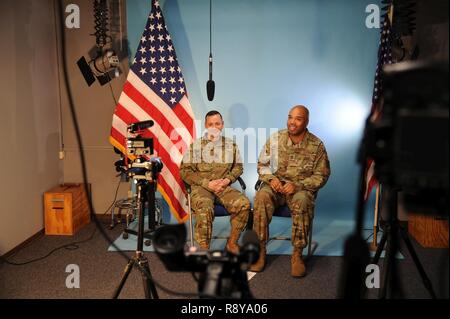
left=77, top=0, right=119, bottom=86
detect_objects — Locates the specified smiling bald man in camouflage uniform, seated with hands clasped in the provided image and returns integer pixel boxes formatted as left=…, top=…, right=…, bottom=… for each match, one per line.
left=251, top=105, right=330, bottom=277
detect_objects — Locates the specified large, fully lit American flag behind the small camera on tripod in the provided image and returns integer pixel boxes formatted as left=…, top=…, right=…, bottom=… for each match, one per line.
left=110, top=0, right=195, bottom=222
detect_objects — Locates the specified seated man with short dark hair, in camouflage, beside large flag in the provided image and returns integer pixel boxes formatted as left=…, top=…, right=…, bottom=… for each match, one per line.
left=180, top=111, right=250, bottom=254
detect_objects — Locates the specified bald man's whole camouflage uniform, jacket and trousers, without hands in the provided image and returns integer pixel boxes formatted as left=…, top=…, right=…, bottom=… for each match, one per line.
left=253, top=130, right=330, bottom=248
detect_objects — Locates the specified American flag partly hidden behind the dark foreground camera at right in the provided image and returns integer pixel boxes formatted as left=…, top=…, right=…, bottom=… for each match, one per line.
left=364, top=6, right=393, bottom=200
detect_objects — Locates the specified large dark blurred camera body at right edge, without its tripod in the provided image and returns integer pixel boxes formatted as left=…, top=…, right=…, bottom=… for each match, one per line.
left=363, top=62, right=449, bottom=214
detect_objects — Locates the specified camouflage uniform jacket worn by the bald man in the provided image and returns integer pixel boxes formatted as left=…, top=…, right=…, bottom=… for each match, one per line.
left=258, top=129, right=330, bottom=192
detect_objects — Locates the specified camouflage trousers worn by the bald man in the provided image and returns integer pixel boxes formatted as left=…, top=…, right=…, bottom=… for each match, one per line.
left=253, top=184, right=315, bottom=248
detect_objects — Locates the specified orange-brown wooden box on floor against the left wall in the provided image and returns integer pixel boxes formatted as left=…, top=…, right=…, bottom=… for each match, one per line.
left=44, top=184, right=91, bottom=235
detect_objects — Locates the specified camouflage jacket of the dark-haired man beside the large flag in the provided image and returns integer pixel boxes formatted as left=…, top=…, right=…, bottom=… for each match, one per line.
left=180, top=136, right=243, bottom=189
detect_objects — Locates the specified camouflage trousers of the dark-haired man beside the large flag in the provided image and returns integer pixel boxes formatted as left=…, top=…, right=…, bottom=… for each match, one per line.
left=191, top=186, right=250, bottom=247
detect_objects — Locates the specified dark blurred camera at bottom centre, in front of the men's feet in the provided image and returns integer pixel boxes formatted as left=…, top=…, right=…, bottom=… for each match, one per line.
left=153, top=224, right=259, bottom=299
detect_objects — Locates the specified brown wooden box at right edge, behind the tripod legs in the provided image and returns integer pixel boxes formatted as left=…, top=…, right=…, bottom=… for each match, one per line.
left=408, top=214, right=448, bottom=248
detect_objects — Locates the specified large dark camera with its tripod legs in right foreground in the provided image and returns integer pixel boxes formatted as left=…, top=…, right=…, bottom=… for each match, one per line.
left=341, top=61, right=449, bottom=298
